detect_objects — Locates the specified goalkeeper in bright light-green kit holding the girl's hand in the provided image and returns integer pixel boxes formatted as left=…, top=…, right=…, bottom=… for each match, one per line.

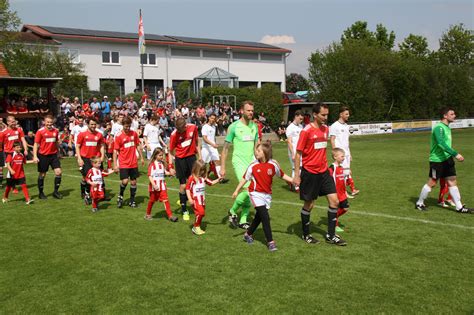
left=220, top=101, right=258, bottom=229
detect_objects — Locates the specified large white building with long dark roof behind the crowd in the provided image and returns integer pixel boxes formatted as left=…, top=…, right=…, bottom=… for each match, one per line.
left=22, top=25, right=291, bottom=93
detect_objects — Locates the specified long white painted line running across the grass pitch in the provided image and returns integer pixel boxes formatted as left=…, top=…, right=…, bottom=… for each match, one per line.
left=20, top=168, right=474, bottom=230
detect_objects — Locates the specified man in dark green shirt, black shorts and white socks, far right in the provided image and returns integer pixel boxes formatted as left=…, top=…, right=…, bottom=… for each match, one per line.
left=415, top=107, right=473, bottom=213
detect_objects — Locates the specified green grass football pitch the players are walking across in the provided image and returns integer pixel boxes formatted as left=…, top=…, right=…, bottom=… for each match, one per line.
left=0, top=129, right=474, bottom=314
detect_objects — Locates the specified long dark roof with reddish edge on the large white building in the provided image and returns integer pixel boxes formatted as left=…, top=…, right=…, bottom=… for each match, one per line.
left=22, top=24, right=291, bottom=53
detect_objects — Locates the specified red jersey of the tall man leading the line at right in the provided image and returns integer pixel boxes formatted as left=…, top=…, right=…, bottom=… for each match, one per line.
left=296, top=124, right=329, bottom=174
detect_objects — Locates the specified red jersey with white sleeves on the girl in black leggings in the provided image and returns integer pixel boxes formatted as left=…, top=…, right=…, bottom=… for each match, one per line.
left=243, top=160, right=285, bottom=194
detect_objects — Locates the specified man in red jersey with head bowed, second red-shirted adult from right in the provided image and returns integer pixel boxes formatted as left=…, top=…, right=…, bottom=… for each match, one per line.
left=169, top=117, right=201, bottom=221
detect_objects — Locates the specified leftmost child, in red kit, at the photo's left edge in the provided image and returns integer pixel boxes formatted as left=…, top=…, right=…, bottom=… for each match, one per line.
left=2, top=142, right=33, bottom=205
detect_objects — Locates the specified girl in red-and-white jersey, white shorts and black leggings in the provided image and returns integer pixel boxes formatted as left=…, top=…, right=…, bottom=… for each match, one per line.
left=232, top=142, right=293, bottom=252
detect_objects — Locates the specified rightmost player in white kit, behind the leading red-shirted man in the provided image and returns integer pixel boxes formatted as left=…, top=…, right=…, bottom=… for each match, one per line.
left=329, top=106, right=359, bottom=196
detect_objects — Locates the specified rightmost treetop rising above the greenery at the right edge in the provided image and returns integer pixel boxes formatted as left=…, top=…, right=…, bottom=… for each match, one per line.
left=438, top=24, right=474, bottom=66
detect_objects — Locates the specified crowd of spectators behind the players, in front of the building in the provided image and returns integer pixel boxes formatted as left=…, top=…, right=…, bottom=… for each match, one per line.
left=2, top=90, right=271, bottom=156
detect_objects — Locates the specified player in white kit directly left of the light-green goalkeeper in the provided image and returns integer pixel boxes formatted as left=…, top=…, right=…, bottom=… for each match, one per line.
left=201, top=114, right=228, bottom=183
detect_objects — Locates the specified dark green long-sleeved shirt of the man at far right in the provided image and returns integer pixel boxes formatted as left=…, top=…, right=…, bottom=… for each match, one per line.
left=430, top=122, right=458, bottom=162
